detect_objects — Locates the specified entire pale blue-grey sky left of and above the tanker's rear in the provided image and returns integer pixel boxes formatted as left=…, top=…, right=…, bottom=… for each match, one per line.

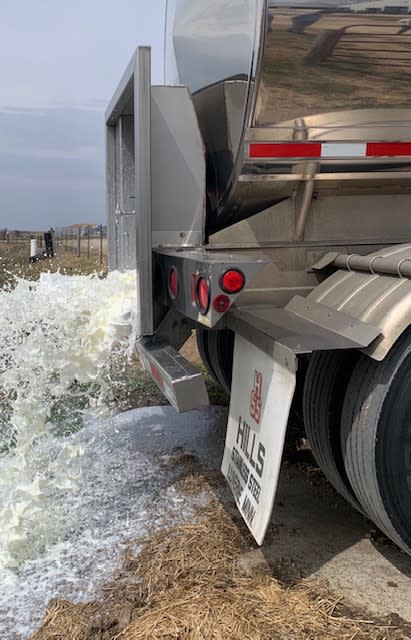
left=0, top=0, right=165, bottom=230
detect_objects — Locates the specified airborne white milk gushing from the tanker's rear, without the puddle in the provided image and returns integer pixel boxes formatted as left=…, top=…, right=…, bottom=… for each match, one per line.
left=0, top=272, right=136, bottom=580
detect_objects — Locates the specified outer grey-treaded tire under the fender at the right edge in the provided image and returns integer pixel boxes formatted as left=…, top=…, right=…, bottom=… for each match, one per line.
left=341, top=329, right=411, bottom=554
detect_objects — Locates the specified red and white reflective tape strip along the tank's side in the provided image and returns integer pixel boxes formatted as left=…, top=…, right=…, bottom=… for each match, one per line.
left=248, top=142, right=411, bottom=158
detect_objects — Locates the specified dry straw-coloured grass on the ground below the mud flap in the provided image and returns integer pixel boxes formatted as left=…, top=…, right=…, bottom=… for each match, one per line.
left=32, top=470, right=409, bottom=640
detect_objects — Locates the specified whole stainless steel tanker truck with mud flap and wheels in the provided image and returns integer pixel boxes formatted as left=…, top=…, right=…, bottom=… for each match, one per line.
left=106, top=0, right=411, bottom=553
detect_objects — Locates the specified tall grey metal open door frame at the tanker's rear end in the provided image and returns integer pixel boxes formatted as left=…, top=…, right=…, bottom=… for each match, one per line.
left=106, top=47, right=154, bottom=336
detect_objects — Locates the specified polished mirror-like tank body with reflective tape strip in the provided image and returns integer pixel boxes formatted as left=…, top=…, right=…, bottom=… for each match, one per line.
left=165, top=0, right=411, bottom=228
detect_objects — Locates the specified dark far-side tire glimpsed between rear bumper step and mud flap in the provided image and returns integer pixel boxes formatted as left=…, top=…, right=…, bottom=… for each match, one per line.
left=197, top=329, right=234, bottom=394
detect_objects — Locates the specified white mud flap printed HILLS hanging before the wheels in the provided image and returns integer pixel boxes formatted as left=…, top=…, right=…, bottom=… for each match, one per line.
left=221, top=334, right=297, bottom=545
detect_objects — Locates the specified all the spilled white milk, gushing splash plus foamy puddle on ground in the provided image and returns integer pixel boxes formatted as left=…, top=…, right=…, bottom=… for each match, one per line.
left=0, top=273, right=193, bottom=640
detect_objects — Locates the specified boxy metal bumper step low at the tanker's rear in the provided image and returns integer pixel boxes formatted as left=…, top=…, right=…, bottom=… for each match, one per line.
left=135, top=336, right=209, bottom=413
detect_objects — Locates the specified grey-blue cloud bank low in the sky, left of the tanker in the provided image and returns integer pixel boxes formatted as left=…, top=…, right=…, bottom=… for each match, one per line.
left=0, top=107, right=106, bottom=230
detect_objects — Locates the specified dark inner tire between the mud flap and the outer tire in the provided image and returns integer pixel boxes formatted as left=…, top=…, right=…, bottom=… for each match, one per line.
left=303, top=351, right=361, bottom=510
